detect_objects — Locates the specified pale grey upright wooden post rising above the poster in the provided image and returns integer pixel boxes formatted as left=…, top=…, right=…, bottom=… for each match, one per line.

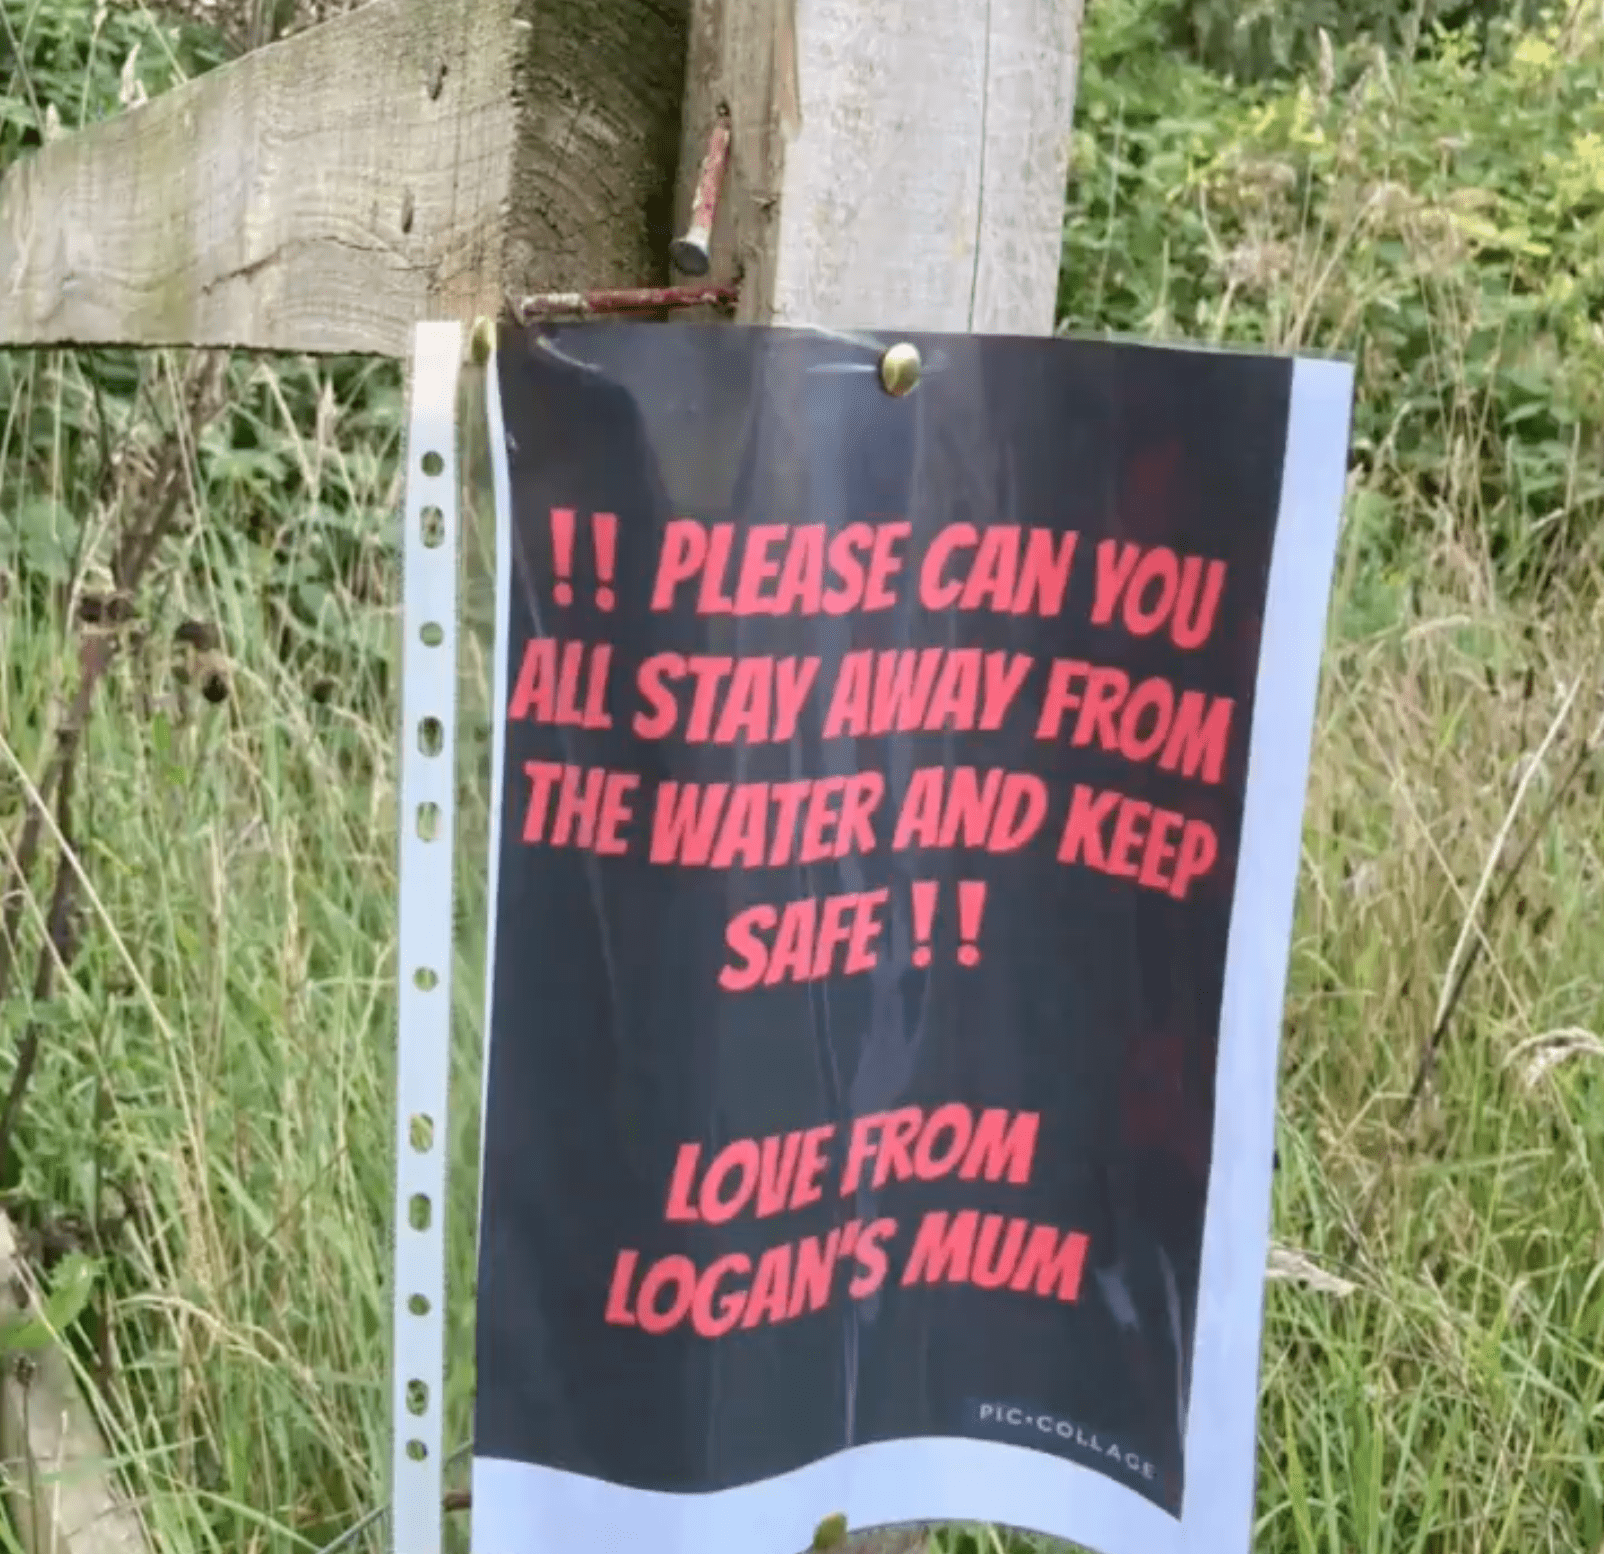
left=680, top=0, right=1083, bottom=334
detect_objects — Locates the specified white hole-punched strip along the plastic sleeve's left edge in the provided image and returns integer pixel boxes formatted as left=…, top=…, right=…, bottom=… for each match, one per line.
left=390, top=324, right=462, bottom=1554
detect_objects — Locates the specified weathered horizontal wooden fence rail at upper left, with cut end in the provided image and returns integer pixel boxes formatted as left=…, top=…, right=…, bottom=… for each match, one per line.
left=0, top=0, right=685, bottom=356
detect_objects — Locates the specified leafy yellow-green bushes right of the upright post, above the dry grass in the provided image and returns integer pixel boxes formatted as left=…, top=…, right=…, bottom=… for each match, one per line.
left=1060, top=3, right=1604, bottom=587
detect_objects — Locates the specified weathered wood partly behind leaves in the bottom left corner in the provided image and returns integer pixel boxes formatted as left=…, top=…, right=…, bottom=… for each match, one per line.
left=0, top=1214, right=151, bottom=1554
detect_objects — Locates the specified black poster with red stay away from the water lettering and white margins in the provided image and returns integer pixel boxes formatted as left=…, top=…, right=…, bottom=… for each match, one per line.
left=473, top=324, right=1352, bottom=1554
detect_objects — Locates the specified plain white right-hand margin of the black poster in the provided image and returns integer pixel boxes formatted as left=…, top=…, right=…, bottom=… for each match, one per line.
left=1182, top=358, right=1354, bottom=1554
